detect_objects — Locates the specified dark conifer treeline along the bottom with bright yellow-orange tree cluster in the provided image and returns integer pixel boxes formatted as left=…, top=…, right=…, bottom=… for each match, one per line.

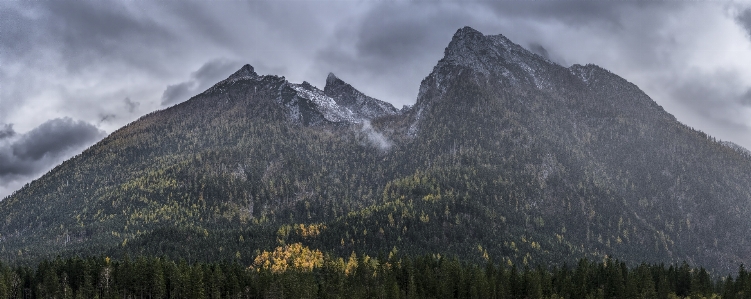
left=0, top=252, right=751, bottom=298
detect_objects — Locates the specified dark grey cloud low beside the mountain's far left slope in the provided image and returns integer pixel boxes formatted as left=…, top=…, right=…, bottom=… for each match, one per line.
left=0, top=117, right=106, bottom=198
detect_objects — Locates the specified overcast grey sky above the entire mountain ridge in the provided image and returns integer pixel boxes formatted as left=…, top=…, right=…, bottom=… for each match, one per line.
left=0, top=0, right=751, bottom=197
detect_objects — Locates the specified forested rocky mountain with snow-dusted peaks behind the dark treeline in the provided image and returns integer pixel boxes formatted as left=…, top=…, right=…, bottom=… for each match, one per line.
left=0, top=27, right=751, bottom=273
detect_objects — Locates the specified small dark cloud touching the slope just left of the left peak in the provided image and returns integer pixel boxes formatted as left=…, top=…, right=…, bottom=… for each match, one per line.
left=162, top=59, right=242, bottom=107
